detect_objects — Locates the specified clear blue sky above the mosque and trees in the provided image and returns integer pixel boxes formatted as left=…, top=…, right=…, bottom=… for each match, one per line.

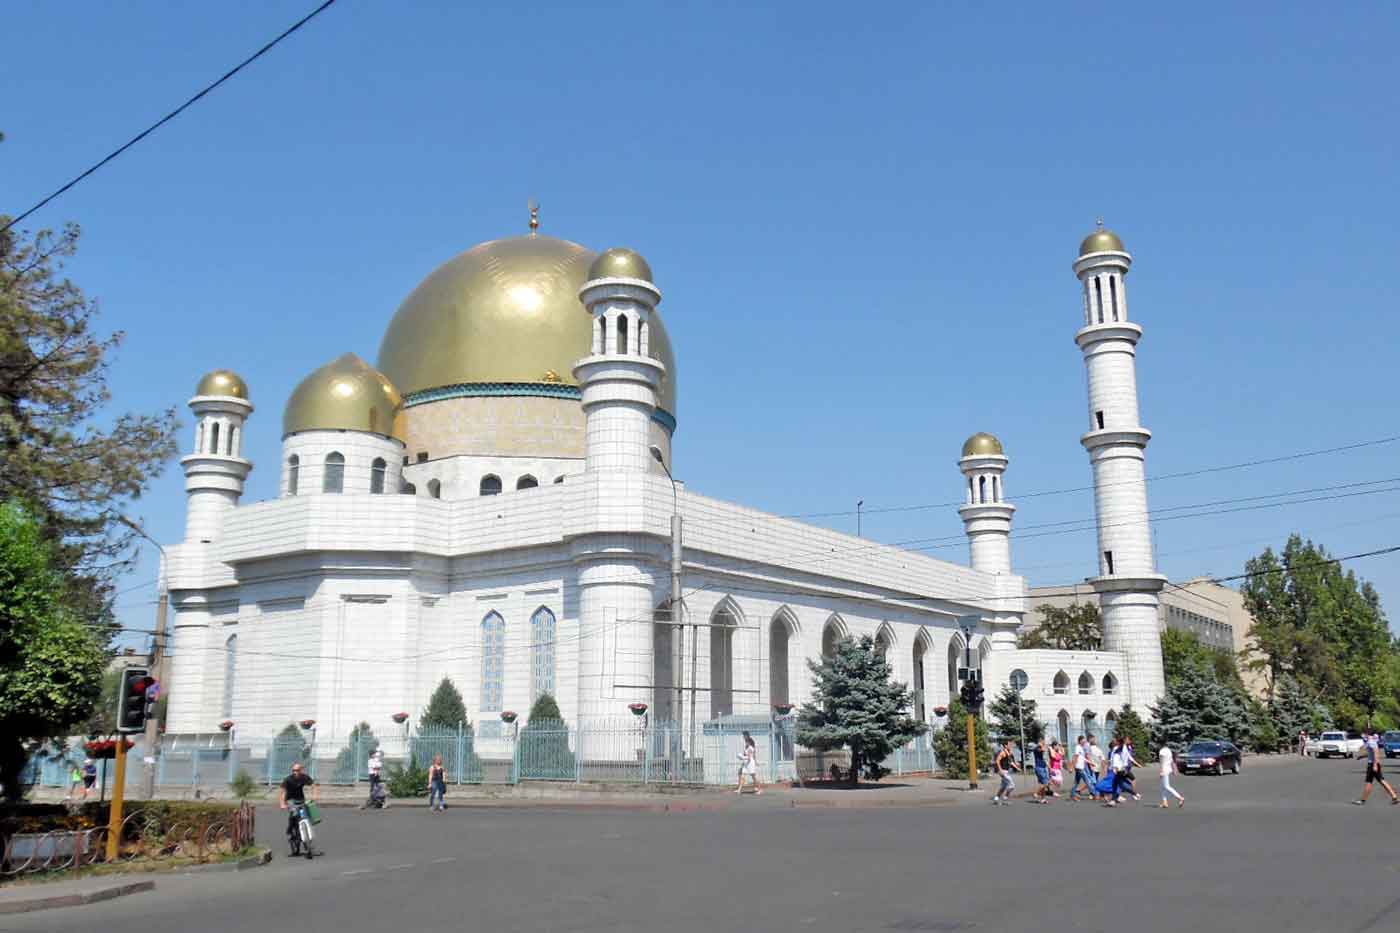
left=0, top=0, right=1400, bottom=638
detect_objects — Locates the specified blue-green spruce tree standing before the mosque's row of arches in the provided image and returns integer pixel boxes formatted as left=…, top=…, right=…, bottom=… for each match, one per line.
left=797, top=635, right=927, bottom=786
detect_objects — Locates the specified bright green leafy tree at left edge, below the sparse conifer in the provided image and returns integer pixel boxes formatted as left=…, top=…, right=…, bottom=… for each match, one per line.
left=0, top=503, right=108, bottom=799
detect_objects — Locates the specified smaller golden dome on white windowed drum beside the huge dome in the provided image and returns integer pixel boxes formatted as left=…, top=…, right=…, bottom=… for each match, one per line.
left=281, top=353, right=403, bottom=440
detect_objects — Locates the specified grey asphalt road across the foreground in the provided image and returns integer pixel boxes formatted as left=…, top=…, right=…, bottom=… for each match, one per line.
left=10, top=759, right=1400, bottom=933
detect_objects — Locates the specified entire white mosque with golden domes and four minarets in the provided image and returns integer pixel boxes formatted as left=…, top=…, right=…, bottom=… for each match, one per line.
left=165, top=220, right=1165, bottom=756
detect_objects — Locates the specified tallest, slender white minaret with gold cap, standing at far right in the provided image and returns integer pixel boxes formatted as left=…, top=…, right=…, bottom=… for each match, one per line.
left=1074, top=221, right=1166, bottom=713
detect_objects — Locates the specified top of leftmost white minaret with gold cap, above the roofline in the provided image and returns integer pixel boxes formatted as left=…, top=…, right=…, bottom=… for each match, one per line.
left=179, top=370, right=253, bottom=544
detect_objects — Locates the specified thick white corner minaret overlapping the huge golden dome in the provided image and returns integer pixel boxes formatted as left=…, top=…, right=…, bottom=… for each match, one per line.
left=570, top=248, right=671, bottom=722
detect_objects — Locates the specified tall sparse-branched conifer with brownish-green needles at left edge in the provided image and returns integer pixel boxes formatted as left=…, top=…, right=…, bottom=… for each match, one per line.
left=0, top=217, right=178, bottom=623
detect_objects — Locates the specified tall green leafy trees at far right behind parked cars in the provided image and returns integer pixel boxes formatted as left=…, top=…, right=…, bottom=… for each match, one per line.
left=1242, top=534, right=1400, bottom=728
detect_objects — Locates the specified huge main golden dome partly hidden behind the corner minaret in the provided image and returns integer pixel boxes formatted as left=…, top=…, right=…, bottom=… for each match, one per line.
left=379, top=235, right=676, bottom=416
